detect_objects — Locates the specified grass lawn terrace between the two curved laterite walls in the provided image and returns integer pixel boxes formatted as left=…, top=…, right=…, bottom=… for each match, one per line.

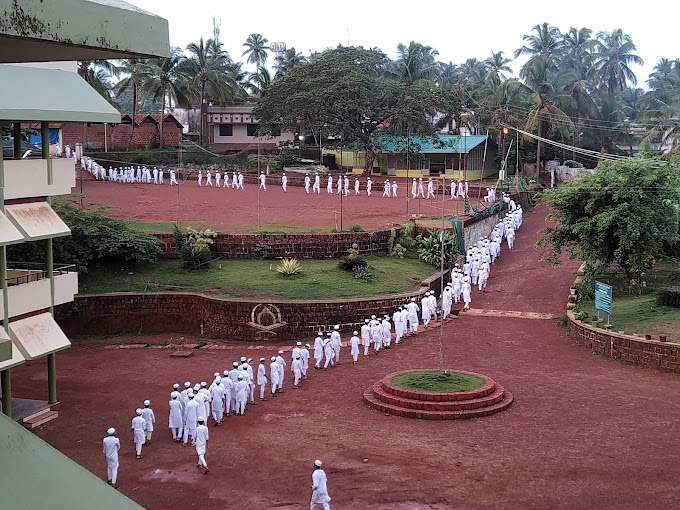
left=80, top=256, right=436, bottom=299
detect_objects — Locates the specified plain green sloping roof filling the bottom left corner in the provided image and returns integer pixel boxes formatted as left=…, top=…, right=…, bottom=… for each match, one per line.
left=0, top=413, right=142, bottom=510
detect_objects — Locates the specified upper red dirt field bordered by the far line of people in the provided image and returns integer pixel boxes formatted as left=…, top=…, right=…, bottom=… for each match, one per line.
left=73, top=173, right=476, bottom=232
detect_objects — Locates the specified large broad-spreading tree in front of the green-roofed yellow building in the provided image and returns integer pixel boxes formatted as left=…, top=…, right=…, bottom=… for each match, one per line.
left=253, top=46, right=454, bottom=172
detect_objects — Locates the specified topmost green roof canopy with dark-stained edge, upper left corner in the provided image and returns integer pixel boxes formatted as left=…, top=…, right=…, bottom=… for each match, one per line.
left=0, top=0, right=170, bottom=63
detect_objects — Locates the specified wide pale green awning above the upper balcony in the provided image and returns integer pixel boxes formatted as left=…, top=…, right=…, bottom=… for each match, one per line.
left=0, top=64, right=120, bottom=123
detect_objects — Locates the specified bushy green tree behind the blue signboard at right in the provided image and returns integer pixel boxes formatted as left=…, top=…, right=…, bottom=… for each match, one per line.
left=537, top=156, right=680, bottom=283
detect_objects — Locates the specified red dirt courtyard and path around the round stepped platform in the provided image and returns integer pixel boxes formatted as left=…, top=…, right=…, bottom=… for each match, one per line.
left=12, top=205, right=680, bottom=510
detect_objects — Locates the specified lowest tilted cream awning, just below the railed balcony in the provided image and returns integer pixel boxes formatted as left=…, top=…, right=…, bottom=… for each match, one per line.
left=9, top=312, right=71, bottom=360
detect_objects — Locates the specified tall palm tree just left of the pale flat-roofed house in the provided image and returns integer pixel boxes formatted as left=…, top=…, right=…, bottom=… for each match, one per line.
left=181, top=37, right=240, bottom=144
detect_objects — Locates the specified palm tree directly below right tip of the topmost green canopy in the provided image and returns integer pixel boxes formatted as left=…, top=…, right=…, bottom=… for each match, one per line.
left=140, top=47, right=188, bottom=147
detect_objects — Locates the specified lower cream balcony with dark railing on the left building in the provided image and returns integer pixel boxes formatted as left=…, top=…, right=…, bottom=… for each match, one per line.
left=0, top=262, right=78, bottom=319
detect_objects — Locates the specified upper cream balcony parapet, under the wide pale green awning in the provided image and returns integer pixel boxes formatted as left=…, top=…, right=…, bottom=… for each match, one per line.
left=3, top=158, right=76, bottom=200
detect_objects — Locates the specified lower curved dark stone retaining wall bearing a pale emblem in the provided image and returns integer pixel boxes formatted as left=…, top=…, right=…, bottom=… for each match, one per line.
left=55, top=273, right=448, bottom=342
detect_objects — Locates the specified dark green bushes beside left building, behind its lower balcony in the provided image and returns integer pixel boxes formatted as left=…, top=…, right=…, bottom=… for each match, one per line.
left=7, top=198, right=162, bottom=272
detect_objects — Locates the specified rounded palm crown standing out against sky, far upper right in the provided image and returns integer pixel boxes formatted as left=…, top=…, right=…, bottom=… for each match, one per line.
left=593, top=28, right=644, bottom=97
